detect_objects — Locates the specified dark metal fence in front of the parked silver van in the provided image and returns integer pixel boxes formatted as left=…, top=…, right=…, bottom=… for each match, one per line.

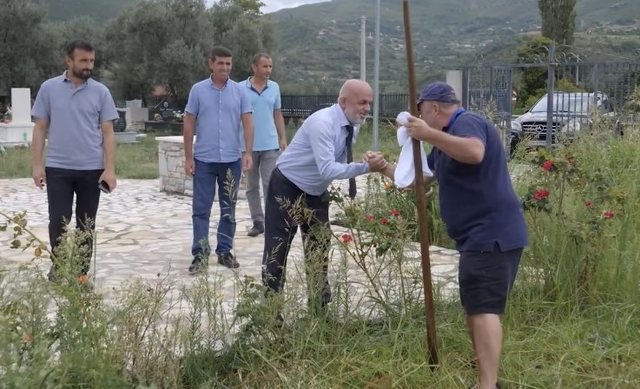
left=461, top=58, right=640, bottom=146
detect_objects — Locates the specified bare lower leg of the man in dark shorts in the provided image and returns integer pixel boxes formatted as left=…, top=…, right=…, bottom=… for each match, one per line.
left=467, top=313, right=502, bottom=389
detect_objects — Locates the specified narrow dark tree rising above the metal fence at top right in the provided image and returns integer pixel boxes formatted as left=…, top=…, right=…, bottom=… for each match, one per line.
left=538, top=0, right=576, bottom=45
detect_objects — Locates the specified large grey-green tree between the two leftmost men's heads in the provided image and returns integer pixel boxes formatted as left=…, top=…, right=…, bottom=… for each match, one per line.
left=105, top=0, right=211, bottom=104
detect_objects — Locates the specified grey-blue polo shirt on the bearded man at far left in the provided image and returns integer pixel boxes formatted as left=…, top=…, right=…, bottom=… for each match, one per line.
left=31, top=72, right=118, bottom=170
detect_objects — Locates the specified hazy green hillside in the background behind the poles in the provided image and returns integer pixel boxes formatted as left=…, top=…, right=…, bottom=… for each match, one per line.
left=268, top=0, right=640, bottom=92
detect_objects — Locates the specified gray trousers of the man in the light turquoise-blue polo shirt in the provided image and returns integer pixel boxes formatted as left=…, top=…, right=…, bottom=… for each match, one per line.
left=247, top=150, right=280, bottom=224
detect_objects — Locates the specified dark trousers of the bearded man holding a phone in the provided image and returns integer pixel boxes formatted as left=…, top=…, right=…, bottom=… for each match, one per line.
left=45, top=167, right=102, bottom=274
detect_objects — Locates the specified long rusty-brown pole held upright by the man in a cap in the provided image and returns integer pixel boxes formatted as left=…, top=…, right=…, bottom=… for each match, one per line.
left=402, top=0, right=438, bottom=369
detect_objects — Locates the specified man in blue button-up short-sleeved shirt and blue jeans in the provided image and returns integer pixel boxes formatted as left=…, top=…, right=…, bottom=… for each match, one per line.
left=183, top=47, right=253, bottom=274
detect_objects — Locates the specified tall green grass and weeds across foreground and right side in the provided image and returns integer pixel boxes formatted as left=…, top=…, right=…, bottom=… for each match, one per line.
left=0, top=122, right=640, bottom=389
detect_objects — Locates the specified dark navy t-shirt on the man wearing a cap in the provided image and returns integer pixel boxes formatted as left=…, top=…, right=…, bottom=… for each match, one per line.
left=428, top=108, right=527, bottom=251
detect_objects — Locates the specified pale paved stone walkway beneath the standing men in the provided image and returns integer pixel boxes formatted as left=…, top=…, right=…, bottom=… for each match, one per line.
left=0, top=179, right=458, bottom=310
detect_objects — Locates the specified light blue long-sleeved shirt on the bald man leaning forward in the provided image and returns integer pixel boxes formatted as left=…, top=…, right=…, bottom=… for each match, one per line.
left=276, top=104, right=369, bottom=196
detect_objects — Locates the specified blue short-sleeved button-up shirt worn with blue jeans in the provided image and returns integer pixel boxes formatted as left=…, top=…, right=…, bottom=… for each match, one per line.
left=185, top=77, right=253, bottom=162
